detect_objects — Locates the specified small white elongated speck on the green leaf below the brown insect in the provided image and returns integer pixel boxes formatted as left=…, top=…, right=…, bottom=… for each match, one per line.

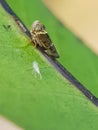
left=32, top=61, right=42, bottom=79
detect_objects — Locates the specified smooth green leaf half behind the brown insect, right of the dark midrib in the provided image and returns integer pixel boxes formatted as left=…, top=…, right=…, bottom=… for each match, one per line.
left=7, top=0, right=98, bottom=97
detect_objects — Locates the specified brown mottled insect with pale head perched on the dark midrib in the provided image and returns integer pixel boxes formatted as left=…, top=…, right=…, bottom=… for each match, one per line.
left=30, top=20, right=59, bottom=58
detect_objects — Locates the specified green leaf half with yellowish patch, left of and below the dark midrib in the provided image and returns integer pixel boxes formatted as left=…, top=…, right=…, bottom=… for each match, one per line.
left=0, top=1, right=98, bottom=130
